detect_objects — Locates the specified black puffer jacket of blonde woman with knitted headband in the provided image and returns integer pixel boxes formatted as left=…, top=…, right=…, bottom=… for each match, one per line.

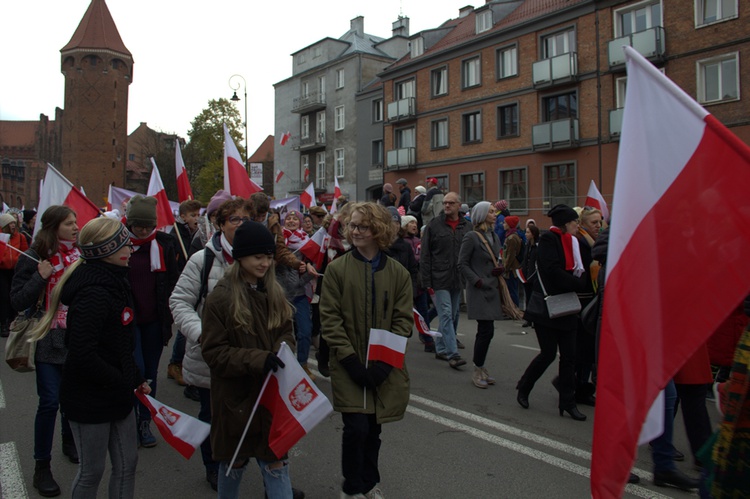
left=60, top=261, right=145, bottom=424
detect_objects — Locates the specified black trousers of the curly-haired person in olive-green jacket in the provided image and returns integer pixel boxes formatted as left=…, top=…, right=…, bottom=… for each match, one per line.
left=341, top=412, right=381, bottom=495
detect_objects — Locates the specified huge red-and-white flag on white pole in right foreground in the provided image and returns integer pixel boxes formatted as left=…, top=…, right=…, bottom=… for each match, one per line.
left=591, top=47, right=750, bottom=498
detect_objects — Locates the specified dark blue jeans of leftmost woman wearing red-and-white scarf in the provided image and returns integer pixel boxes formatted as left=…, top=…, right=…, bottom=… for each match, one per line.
left=34, top=362, right=71, bottom=461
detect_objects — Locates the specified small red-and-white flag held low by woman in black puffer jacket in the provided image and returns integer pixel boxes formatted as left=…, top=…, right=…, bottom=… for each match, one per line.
left=135, top=390, right=211, bottom=459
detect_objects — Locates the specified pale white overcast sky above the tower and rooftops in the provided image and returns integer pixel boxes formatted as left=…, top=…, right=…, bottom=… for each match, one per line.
left=0, top=0, right=462, bottom=153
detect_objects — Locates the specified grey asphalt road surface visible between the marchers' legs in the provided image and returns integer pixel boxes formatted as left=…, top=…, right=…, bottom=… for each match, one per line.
left=0, top=314, right=717, bottom=499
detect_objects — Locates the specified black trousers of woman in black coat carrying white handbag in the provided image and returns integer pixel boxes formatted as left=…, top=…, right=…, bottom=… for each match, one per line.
left=518, top=324, right=576, bottom=409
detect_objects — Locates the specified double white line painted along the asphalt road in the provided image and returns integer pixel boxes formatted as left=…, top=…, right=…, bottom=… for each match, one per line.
left=406, top=406, right=669, bottom=499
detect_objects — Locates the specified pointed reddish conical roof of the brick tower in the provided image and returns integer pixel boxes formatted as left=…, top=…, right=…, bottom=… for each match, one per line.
left=60, top=0, right=133, bottom=59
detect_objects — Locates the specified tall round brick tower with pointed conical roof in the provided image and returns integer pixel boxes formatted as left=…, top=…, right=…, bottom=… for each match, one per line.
left=60, top=0, right=133, bottom=206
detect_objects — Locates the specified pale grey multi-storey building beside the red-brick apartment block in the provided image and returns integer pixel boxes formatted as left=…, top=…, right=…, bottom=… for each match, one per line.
left=274, top=17, right=409, bottom=202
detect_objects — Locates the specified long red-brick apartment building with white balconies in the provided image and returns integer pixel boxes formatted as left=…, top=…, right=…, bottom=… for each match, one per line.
left=378, top=0, right=750, bottom=220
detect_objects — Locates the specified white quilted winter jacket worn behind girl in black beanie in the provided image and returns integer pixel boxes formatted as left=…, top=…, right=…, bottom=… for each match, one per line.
left=169, top=237, right=229, bottom=388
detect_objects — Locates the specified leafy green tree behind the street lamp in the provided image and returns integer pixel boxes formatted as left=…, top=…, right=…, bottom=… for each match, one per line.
left=182, top=98, right=246, bottom=203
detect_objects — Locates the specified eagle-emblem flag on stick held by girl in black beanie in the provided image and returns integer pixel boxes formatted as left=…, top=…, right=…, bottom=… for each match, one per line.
left=258, top=343, right=333, bottom=459
